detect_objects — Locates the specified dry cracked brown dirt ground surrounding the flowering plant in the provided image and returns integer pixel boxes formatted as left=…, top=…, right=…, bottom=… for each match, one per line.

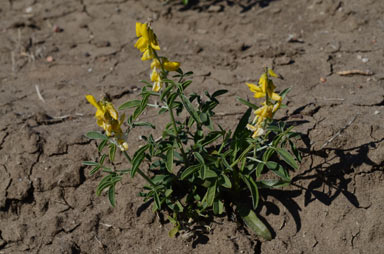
left=0, top=0, right=384, bottom=253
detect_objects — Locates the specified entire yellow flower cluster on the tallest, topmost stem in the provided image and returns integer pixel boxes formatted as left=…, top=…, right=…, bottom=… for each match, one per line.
left=135, top=22, right=180, bottom=92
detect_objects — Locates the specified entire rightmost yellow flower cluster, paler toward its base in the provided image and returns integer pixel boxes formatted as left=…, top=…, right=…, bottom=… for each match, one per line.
left=246, top=68, right=282, bottom=138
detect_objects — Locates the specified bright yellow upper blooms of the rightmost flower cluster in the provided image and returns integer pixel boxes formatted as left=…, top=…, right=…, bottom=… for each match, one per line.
left=246, top=69, right=282, bottom=101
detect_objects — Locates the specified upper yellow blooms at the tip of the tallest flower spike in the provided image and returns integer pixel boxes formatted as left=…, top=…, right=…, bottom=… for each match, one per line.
left=135, top=22, right=160, bottom=61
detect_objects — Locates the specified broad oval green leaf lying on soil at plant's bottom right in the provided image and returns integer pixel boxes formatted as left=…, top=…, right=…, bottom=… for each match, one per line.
left=237, top=204, right=272, bottom=241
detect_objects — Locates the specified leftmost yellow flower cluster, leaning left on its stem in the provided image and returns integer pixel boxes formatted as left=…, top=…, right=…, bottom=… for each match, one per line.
left=85, top=95, right=128, bottom=151
